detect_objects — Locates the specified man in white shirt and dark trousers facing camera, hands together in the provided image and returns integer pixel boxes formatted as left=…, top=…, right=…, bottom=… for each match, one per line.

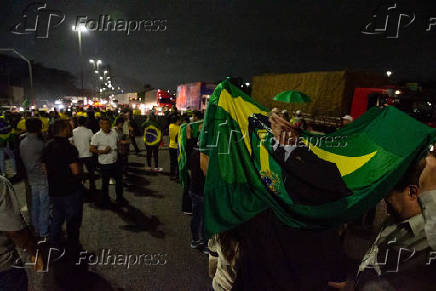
left=90, top=117, right=127, bottom=205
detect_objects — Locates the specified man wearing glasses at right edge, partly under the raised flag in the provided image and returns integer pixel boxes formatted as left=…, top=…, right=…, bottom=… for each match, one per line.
left=355, top=151, right=436, bottom=290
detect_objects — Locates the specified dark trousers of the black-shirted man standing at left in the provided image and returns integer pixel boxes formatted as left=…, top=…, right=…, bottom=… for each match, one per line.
left=50, top=189, right=83, bottom=244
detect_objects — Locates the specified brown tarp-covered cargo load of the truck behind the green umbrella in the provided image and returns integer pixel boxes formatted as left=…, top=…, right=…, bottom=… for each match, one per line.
left=252, top=70, right=390, bottom=116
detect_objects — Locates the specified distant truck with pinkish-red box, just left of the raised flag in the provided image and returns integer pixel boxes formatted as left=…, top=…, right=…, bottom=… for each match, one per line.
left=176, top=82, right=216, bottom=111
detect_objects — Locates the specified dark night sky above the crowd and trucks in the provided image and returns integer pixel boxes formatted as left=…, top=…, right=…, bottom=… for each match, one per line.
left=0, top=0, right=436, bottom=91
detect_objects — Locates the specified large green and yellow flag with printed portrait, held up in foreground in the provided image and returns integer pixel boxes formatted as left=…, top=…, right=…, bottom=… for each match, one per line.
left=200, top=80, right=436, bottom=236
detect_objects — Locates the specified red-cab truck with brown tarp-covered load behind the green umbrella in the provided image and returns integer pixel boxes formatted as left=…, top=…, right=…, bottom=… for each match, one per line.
left=252, top=70, right=436, bottom=127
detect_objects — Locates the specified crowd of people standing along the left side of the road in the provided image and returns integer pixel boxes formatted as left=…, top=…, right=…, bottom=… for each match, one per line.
left=0, top=105, right=187, bottom=290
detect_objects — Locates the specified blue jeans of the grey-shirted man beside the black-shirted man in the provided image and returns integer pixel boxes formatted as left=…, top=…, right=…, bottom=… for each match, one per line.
left=30, top=185, right=50, bottom=237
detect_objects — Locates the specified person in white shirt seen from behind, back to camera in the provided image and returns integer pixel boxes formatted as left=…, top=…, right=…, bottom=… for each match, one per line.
left=73, top=116, right=96, bottom=193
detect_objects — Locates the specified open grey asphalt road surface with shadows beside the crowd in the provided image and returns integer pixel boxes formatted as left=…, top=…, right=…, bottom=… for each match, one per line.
left=15, top=143, right=211, bottom=291
